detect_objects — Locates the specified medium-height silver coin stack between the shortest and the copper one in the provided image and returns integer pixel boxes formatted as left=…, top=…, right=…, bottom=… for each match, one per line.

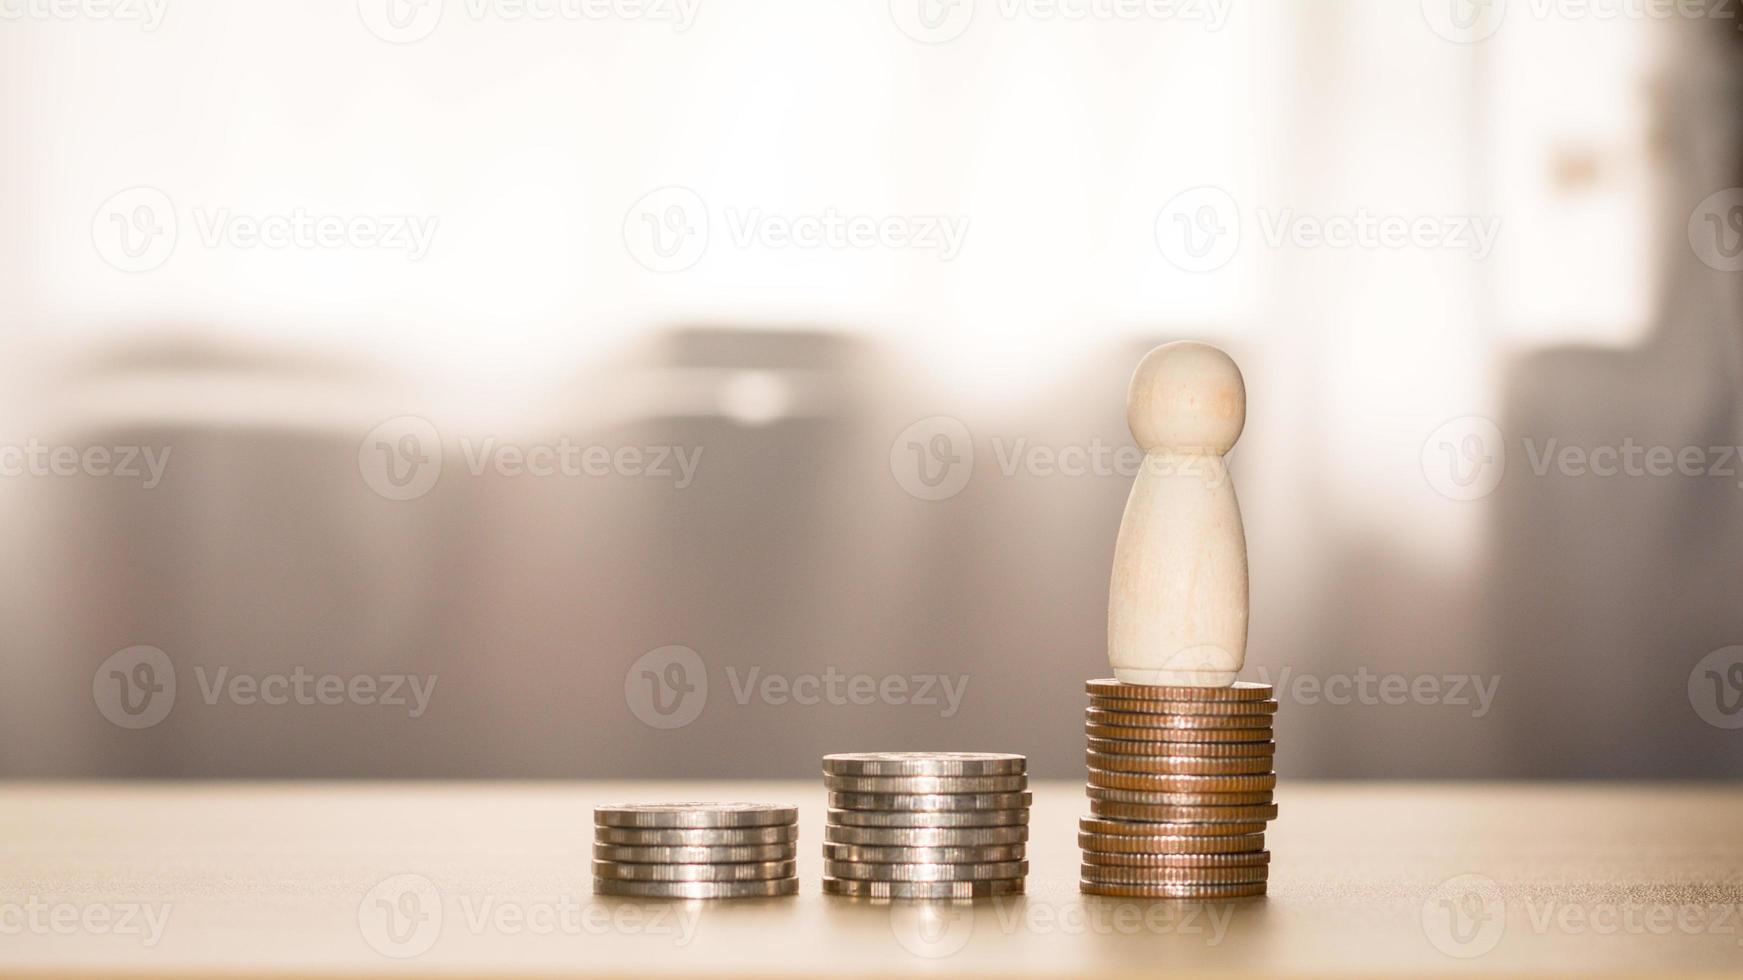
left=823, top=752, right=1032, bottom=898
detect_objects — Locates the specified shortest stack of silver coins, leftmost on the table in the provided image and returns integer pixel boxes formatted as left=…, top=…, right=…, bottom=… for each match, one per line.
left=593, top=804, right=798, bottom=898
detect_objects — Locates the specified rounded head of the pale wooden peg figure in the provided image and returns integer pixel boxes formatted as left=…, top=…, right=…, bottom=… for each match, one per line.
left=1126, top=340, right=1246, bottom=455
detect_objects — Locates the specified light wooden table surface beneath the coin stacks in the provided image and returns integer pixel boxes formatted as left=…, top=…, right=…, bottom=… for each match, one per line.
left=0, top=781, right=1743, bottom=977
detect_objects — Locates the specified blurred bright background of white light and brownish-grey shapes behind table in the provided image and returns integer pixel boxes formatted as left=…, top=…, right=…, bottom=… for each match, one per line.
left=0, top=0, right=1743, bottom=778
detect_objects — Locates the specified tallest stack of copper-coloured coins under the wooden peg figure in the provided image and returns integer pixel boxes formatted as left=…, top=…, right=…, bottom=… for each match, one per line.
left=1077, top=680, right=1278, bottom=898
